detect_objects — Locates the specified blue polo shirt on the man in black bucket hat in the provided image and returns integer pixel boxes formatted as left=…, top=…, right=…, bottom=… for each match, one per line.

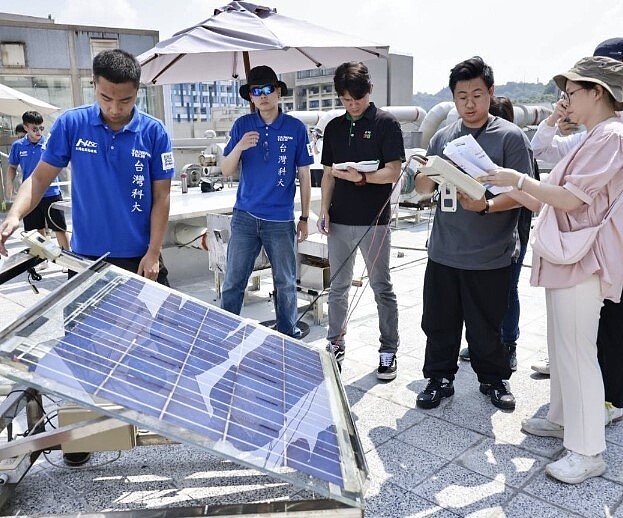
left=223, top=110, right=314, bottom=221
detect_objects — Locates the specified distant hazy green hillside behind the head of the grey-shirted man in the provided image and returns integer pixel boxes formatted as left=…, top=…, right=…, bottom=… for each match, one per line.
left=413, top=81, right=558, bottom=111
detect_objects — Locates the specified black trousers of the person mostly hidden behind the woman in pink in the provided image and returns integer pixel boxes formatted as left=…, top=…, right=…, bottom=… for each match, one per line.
left=597, top=294, right=623, bottom=408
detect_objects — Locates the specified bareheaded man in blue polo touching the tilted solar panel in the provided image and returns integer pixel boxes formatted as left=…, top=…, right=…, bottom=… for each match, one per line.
left=0, top=49, right=174, bottom=284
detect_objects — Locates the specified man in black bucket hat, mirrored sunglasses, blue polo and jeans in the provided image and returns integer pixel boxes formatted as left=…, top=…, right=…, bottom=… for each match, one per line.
left=221, top=66, right=314, bottom=337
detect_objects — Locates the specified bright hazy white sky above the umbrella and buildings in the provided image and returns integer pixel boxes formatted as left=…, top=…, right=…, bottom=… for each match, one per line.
left=0, top=0, right=623, bottom=94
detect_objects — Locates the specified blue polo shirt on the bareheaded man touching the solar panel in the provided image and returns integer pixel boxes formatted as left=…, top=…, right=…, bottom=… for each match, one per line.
left=41, top=103, right=175, bottom=258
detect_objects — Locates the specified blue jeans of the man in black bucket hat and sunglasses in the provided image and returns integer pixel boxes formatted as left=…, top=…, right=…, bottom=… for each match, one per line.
left=221, top=209, right=298, bottom=336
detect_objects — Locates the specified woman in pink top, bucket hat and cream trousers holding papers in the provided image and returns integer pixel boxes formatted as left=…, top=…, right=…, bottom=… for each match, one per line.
left=480, top=56, right=623, bottom=484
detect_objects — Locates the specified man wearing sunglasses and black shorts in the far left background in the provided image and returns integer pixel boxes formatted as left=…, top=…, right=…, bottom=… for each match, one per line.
left=5, top=111, right=69, bottom=250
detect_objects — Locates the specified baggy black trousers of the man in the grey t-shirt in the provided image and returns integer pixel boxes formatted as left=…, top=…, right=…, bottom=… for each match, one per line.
left=422, top=259, right=511, bottom=383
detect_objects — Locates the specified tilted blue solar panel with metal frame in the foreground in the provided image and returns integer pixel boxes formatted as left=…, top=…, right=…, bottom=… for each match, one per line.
left=0, top=264, right=368, bottom=507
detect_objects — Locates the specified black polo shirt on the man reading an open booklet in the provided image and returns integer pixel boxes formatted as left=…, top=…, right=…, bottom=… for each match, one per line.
left=322, top=103, right=405, bottom=225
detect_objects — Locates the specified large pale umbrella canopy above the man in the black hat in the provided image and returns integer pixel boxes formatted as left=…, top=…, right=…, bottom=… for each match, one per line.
left=138, top=2, right=389, bottom=84
